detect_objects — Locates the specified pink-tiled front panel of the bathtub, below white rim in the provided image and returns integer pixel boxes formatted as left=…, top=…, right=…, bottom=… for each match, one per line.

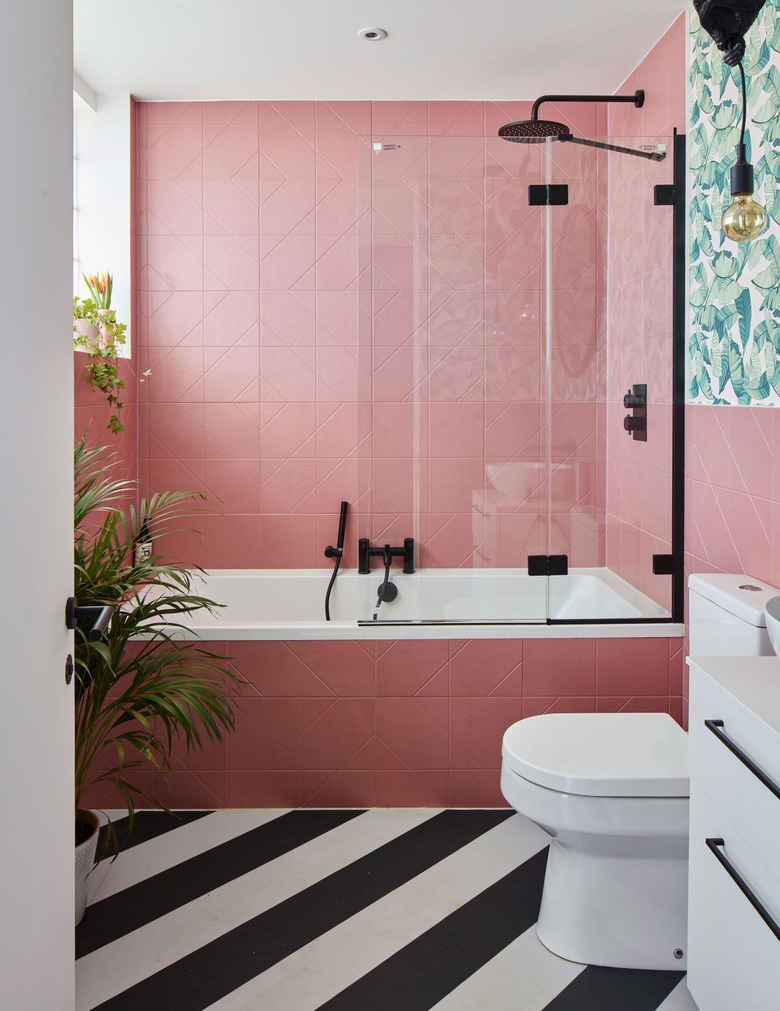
left=82, top=639, right=682, bottom=808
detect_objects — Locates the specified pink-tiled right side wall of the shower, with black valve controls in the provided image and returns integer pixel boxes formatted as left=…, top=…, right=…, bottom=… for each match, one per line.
left=605, top=15, right=686, bottom=608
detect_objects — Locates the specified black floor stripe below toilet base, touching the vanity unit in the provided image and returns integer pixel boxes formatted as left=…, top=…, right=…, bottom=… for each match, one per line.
left=545, top=966, right=685, bottom=1011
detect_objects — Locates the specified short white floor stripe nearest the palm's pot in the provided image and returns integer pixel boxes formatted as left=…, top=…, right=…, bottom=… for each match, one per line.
left=88, top=810, right=287, bottom=902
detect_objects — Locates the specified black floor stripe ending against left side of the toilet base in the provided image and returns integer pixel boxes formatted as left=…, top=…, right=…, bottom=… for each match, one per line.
left=318, top=847, right=549, bottom=1011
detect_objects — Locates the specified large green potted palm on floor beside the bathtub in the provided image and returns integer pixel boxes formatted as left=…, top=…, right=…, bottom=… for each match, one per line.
left=74, top=439, right=240, bottom=923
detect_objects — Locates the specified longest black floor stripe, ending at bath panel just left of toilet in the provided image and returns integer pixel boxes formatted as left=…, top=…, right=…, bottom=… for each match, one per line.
left=94, top=810, right=514, bottom=1011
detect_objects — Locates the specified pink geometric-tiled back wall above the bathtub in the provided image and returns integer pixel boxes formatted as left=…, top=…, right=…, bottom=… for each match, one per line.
left=136, top=102, right=605, bottom=567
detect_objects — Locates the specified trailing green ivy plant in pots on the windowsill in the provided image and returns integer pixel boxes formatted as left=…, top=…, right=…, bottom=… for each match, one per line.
left=73, top=295, right=127, bottom=435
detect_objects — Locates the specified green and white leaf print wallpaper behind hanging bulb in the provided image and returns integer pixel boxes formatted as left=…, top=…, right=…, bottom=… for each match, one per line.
left=688, top=0, right=780, bottom=406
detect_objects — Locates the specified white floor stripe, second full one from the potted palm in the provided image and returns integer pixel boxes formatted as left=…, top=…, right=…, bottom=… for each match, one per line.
left=76, top=808, right=438, bottom=1011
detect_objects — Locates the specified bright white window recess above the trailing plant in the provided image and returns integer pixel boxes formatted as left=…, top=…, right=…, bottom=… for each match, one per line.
left=75, top=94, right=131, bottom=335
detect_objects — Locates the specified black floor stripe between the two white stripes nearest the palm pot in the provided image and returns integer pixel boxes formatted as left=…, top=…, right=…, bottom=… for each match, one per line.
left=76, top=810, right=363, bottom=958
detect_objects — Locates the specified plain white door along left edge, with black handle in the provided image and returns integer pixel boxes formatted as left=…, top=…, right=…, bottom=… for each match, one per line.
left=0, top=0, right=74, bottom=1011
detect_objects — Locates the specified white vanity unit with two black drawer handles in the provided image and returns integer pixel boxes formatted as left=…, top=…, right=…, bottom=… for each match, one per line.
left=688, top=656, right=780, bottom=1011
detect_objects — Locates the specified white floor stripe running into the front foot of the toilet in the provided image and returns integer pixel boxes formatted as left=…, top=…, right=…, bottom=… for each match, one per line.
left=435, top=927, right=585, bottom=1011
